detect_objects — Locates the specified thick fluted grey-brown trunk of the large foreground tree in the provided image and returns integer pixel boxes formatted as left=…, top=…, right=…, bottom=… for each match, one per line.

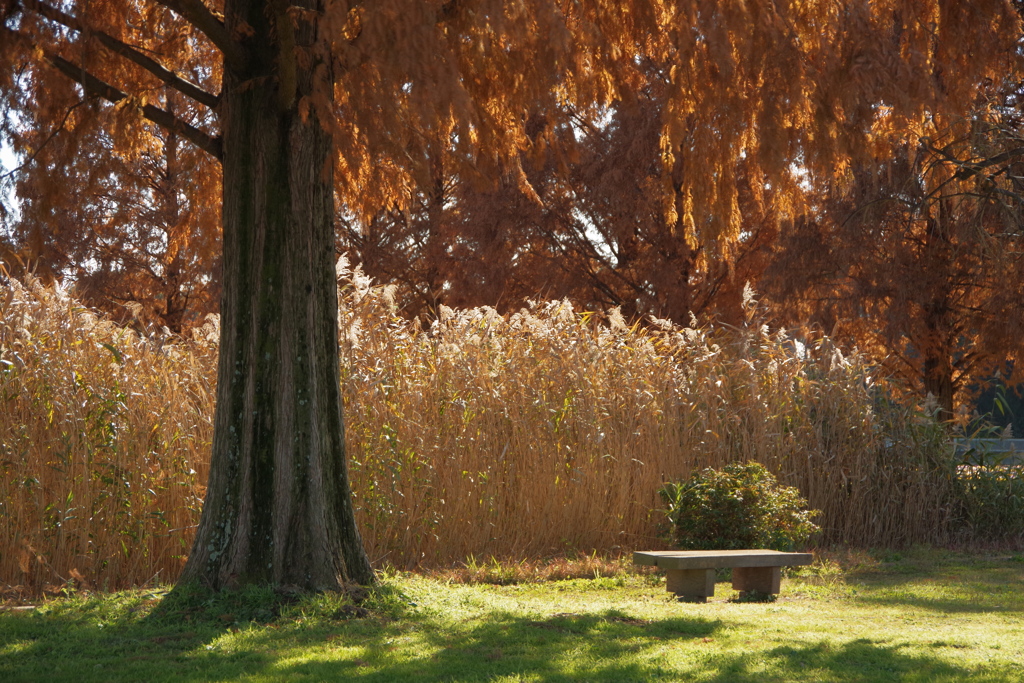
left=182, top=0, right=374, bottom=590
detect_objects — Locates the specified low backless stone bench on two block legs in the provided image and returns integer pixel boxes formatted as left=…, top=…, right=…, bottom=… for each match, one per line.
left=633, top=550, right=814, bottom=602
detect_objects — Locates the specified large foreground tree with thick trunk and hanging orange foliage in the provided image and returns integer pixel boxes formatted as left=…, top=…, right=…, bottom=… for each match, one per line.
left=0, top=0, right=1019, bottom=589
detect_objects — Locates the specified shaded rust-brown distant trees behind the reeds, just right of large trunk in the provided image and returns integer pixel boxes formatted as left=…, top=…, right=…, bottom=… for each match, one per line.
left=339, top=67, right=777, bottom=323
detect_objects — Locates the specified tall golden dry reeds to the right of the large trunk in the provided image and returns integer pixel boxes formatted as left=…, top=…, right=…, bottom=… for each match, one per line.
left=344, top=266, right=957, bottom=566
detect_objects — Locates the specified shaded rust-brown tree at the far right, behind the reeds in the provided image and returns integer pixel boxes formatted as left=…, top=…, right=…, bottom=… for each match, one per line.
left=762, top=102, right=1024, bottom=421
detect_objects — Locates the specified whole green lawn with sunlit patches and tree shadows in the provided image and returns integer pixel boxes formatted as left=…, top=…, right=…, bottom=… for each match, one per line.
left=0, top=550, right=1024, bottom=683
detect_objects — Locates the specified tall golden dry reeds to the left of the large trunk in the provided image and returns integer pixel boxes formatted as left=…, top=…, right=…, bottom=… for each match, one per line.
left=0, top=281, right=216, bottom=590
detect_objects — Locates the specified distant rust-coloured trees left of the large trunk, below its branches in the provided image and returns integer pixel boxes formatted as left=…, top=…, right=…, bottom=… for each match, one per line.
left=4, top=96, right=220, bottom=334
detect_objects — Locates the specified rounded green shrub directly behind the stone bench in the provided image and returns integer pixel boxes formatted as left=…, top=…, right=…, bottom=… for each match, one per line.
left=659, top=462, right=818, bottom=551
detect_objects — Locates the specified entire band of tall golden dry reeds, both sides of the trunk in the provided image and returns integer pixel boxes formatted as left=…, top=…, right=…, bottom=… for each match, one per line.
left=0, top=271, right=961, bottom=590
